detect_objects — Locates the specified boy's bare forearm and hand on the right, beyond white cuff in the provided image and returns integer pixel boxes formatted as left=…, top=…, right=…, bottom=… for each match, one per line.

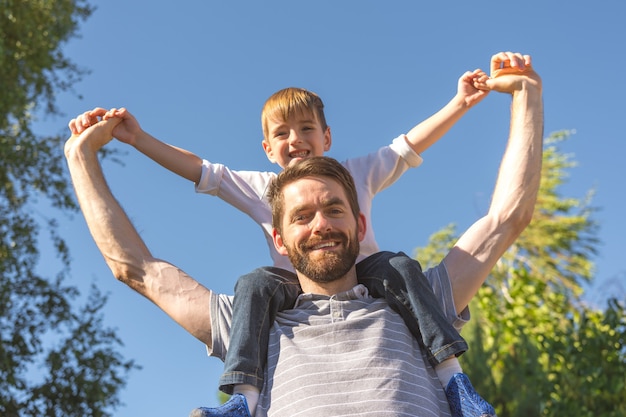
left=406, top=69, right=489, bottom=154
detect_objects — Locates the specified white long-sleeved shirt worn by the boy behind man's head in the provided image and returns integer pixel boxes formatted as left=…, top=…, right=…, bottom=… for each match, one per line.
left=196, top=135, right=422, bottom=271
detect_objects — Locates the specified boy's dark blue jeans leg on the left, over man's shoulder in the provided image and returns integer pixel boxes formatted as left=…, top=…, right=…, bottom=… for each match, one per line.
left=219, top=267, right=300, bottom=394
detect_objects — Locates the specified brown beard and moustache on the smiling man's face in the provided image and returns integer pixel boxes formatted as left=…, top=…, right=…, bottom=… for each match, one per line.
left=287, top=229, right=360, bottom=283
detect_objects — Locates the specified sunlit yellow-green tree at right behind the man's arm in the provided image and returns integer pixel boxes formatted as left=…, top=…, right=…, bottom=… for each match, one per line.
left=417, top=132, right=626, bottom=417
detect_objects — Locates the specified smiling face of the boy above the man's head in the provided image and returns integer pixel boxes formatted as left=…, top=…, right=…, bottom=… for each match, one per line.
left=263, top=112, right=331, bottom=168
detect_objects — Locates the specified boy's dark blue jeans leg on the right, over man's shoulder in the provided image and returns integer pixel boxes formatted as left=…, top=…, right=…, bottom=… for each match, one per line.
left=357, top=252, right=467, bottom=366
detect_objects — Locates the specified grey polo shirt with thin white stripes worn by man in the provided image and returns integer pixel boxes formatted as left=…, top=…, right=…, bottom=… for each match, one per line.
left=209, top=264, right=468, bottom=417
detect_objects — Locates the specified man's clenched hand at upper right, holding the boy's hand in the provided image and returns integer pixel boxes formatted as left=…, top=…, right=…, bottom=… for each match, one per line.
left=474, top=52, right=541, bottom=94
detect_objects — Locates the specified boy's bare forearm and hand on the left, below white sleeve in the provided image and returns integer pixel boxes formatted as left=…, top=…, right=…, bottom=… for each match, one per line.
left=72, top=107, right=202, bottom=184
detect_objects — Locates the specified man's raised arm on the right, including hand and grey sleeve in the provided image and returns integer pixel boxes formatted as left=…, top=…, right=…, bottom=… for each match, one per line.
left=444, top=52, right=543, bottom=312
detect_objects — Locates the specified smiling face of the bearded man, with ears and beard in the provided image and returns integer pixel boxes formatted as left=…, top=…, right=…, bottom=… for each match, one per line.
left=274, top=177, right=365, bottom=283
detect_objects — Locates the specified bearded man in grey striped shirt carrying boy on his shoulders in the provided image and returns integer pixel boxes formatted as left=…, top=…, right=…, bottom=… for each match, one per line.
left=66, top=52, right=543, bottom=416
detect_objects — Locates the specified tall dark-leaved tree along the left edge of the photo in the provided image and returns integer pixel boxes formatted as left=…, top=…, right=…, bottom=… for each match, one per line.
left=0, top=0, right=134, bottom=417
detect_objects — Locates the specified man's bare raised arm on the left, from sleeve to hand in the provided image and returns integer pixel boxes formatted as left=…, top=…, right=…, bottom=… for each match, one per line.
left=65, top=119, right=211, bottom=346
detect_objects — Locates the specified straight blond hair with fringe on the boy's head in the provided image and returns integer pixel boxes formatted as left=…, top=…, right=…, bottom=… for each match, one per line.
left=261, top=87, right=328, bottom=141
